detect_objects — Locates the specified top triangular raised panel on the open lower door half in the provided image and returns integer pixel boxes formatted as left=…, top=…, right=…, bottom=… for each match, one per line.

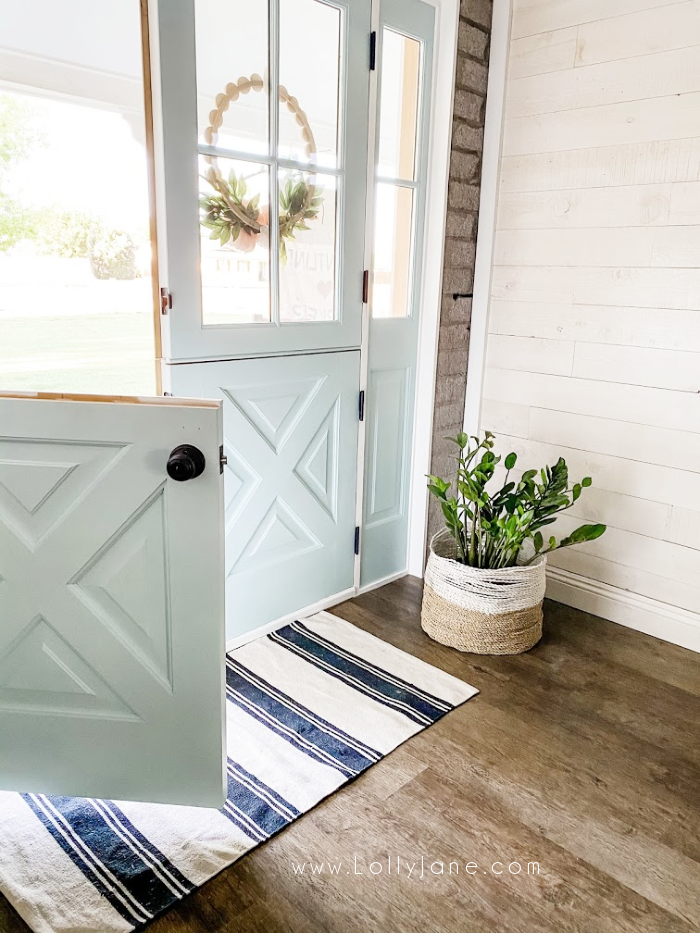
left=0, top=438, right=128, bottom=550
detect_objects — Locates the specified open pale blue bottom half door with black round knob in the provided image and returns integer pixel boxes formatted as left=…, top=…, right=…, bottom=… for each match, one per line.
left=0, top=396, right=225, bottom=806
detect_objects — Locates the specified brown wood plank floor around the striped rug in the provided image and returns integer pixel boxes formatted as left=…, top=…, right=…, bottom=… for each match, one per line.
left=0, top=578, right=700, bottom=933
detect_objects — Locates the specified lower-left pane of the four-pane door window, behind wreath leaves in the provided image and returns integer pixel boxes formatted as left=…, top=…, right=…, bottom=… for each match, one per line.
left=199, top=156, right=274, bottom=326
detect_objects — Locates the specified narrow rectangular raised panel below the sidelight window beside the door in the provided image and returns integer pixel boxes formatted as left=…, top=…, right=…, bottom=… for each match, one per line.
left=366, top=369, right=408, bottom=527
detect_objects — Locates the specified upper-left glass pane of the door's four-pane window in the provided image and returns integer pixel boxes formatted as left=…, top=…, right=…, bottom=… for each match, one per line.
left=195, top=0, right=270, bottom=155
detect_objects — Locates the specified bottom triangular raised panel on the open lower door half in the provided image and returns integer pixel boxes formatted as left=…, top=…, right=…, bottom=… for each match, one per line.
left=0, top=615, right=139, bottom=721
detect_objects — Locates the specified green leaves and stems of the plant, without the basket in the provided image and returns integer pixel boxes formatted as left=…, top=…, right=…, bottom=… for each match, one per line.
left=428, top=431, right=605, bottom=569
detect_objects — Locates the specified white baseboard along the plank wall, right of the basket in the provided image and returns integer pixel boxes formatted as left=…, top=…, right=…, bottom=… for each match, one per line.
left=547, top=567, right=700, bottom=652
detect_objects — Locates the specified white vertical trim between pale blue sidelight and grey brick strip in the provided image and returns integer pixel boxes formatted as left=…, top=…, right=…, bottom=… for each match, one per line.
left=407, top=0, right=459, bottom=577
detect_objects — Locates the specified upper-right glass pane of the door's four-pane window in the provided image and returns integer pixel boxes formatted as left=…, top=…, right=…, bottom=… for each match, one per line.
left=279, top=0, right=341, bottom=168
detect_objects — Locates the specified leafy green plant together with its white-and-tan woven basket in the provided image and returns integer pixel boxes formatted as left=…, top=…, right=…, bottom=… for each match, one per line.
left=421, top=431, right=605, bottom=654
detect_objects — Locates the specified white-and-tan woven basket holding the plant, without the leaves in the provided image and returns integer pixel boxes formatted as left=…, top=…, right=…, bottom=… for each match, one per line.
left=421, top=529, right=547, bottom=654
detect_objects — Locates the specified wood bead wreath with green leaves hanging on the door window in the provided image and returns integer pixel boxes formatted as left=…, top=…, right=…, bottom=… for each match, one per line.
left=199, top=74, right=323, bottom=263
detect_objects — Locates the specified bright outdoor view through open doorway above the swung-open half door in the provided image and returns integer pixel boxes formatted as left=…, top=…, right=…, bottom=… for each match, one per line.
left=0, top=0, right=157, bottom=395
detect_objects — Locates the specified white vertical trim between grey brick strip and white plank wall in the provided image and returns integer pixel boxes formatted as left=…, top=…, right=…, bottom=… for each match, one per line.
left=464, top=0, right=513, bottom=434
